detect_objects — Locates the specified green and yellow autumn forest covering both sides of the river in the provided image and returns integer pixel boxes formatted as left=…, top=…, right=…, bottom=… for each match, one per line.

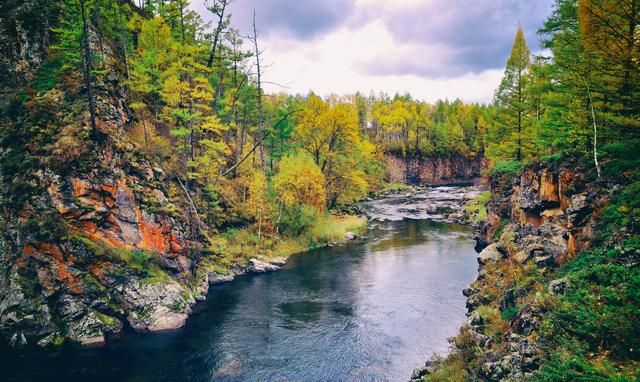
left=0, top=0, right=640, bottom=381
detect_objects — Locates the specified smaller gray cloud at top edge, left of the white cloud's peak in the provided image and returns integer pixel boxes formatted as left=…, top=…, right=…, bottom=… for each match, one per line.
left=222, top=0, right=354, bottom=40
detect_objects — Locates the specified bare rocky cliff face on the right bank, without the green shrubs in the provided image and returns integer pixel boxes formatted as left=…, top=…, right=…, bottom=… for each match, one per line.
left=414, top=161, right=617, bottom=381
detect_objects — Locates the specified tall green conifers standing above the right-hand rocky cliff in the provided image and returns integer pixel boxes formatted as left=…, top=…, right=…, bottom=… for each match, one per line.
left=486, top=0, right=640, bottom=173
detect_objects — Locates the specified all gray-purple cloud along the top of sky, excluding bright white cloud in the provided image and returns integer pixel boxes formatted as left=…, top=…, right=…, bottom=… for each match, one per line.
left=193, top=0, right=554, bottom=78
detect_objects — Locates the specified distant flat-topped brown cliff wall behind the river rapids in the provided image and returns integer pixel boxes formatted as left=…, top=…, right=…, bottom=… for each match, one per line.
left=384, top=154, right=483, bottom=185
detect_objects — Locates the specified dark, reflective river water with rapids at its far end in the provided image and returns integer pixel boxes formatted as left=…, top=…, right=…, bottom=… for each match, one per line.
left=0, top=189, right=477, bottom=382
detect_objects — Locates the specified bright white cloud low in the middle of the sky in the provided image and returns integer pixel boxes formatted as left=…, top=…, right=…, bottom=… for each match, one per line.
left=264, top=20, right=502, bottom=102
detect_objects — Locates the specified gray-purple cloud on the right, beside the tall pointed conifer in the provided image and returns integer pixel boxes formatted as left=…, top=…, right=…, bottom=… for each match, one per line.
left=357, top=0, right=553, bottom=77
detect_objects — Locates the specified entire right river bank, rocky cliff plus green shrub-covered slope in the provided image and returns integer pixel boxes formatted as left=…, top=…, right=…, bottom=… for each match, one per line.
left=411, top=158, right=638, bottom=382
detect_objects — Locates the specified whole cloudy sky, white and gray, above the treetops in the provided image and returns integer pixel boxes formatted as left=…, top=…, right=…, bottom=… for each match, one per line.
left=192, top=0, right=553, bottom=102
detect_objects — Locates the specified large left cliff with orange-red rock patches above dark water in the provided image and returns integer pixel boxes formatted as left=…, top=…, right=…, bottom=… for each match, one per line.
left=0, top=1, right=208, bottom=346
